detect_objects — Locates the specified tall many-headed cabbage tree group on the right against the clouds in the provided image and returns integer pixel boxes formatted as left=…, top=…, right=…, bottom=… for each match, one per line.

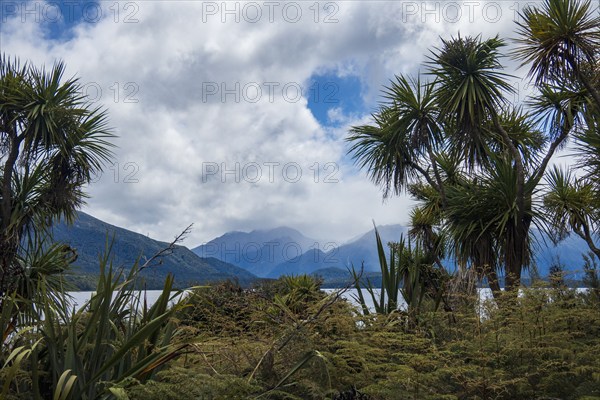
left=348, top=0, right=600, bottom=291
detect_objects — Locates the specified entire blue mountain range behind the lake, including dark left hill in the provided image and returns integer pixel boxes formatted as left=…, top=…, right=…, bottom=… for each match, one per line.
left=53, top=212, right=587, bottom=289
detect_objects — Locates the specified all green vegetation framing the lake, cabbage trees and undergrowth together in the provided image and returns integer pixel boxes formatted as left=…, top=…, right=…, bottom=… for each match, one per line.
left=0, top=0, right=600, bottom=400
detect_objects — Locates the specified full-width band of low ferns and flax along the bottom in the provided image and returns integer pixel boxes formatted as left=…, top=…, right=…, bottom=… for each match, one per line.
left=0, top=247, right=600, bottom=400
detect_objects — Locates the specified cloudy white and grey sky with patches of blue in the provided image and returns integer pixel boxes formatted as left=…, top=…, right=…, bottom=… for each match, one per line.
left=0, top=0, right=564, bottom=247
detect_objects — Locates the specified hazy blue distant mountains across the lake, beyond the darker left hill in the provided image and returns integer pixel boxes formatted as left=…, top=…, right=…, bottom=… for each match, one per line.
left=192, top=225, right=588, bottom=284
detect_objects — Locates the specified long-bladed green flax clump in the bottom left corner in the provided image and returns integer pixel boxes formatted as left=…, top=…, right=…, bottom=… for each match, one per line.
left=0, top=245, right=186, bottom=400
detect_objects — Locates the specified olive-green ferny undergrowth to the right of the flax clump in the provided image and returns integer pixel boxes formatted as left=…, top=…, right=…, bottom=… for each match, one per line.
left=119, top=278, right=600, bottom=400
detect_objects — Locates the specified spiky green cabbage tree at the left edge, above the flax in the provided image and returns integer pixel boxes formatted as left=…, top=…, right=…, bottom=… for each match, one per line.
left=0, top=55, right=113, bottom=301
